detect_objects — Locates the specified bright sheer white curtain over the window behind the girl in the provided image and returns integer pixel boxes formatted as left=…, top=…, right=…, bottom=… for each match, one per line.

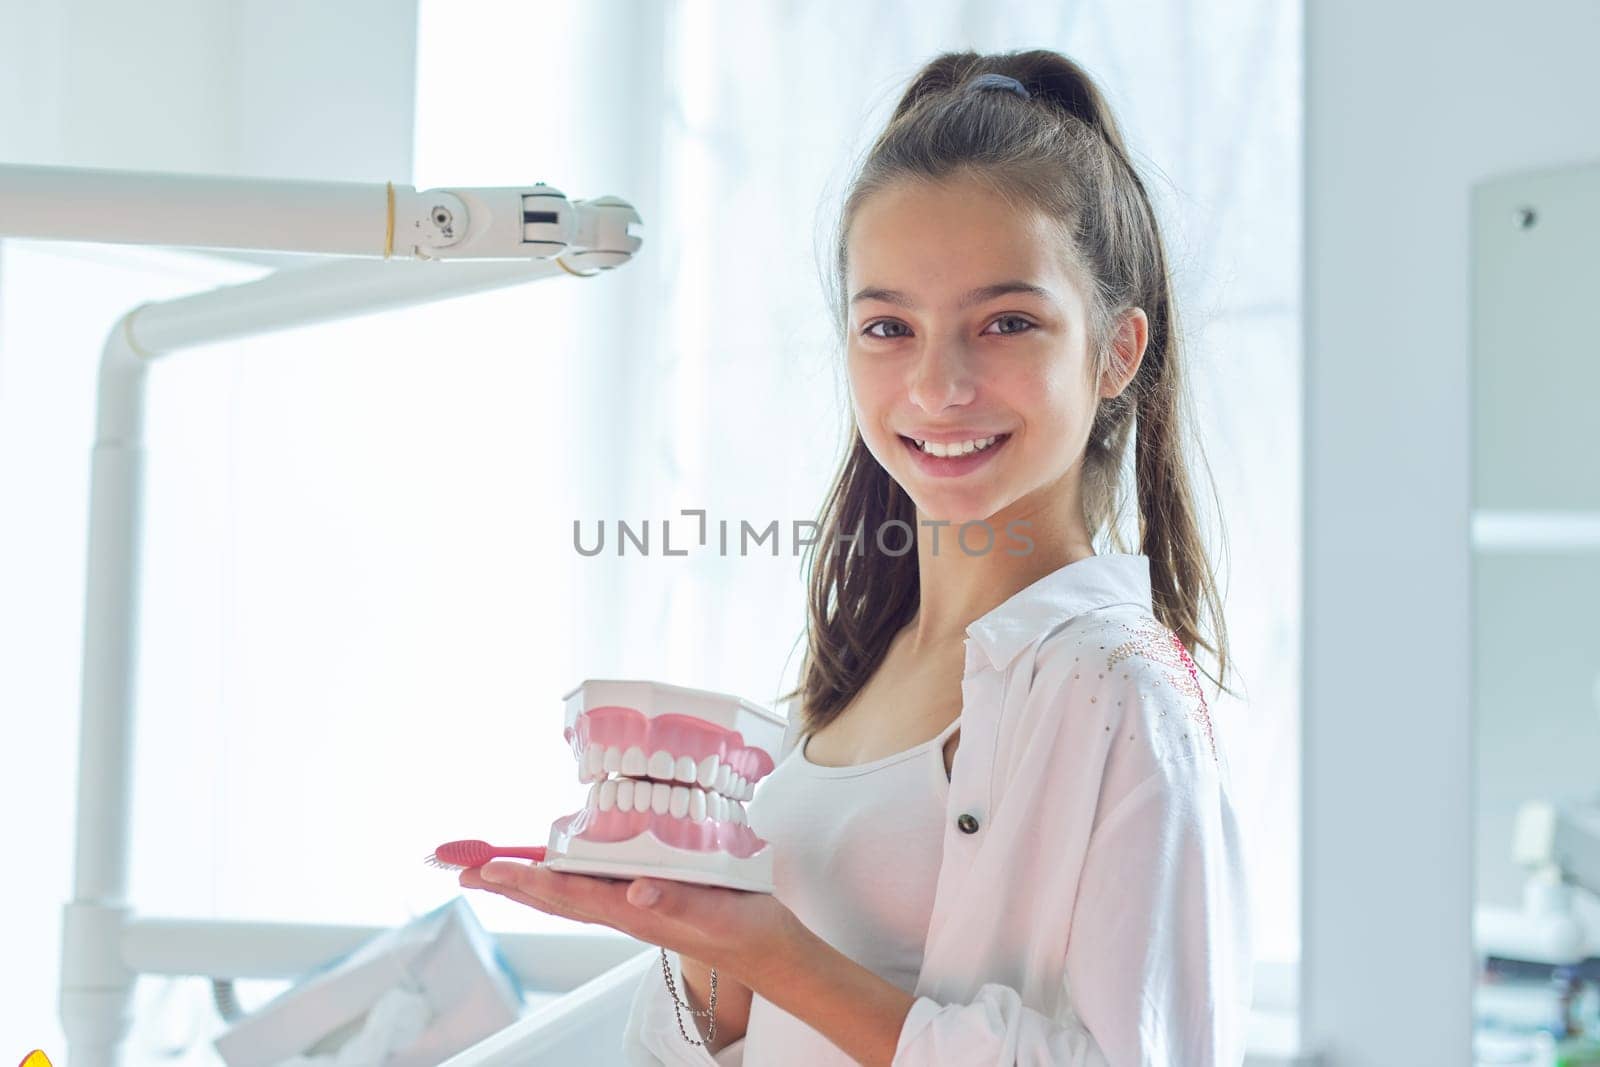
left=0, top=0, right=1301, bottom=1062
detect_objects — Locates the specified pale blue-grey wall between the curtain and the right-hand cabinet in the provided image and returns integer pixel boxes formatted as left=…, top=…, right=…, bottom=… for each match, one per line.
left=1302, top=0, right=1600, bottom=1064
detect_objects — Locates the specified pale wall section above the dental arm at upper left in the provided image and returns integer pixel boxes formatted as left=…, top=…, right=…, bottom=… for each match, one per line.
left=0, top=0, right=418, bottom=182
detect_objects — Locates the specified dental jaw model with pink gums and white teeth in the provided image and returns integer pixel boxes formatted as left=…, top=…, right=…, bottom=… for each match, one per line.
left=544, top=678, right=786, bottom=893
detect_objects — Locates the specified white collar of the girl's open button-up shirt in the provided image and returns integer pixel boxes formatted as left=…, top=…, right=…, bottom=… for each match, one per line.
left=966, top=552, right=1154, bottom=670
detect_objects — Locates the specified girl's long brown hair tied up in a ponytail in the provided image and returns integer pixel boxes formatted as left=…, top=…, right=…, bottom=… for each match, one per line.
left=781, top=50, right=1229, bottom=733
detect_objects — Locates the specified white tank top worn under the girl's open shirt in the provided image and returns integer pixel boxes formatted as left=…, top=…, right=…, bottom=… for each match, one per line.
left=742, top=717, right=962, bottom=1067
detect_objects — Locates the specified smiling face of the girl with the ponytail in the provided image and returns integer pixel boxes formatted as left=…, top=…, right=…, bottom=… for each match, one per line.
left=845, top=179, right=1142, bottom=536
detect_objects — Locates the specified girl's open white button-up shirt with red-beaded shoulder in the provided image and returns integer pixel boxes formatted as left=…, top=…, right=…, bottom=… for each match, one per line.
left=624, top=553, right=1253, bottom=1067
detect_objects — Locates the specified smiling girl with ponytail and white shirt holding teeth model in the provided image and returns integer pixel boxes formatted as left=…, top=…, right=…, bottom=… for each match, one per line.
left=462, top=51, right=1251, bottom=1067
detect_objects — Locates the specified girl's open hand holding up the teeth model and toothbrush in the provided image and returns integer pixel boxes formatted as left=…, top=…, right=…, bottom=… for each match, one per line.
left=459, top=859, right=813, bottom=990
